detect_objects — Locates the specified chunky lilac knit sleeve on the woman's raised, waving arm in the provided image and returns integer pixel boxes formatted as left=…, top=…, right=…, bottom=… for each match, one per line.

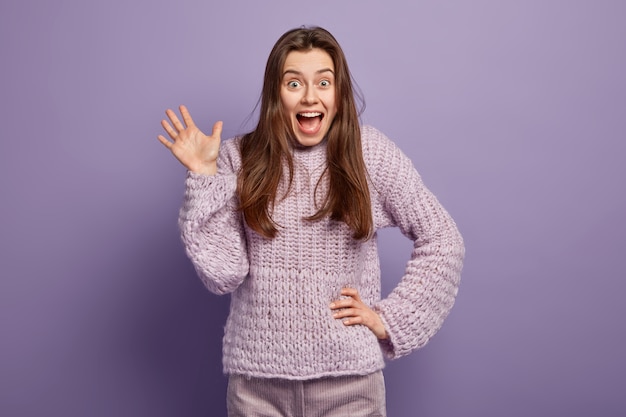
left=178, top=139, right=249, bottom=294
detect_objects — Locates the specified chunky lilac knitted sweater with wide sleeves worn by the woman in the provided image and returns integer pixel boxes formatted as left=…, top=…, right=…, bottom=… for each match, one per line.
left=179, top=126, right=464, bottom=379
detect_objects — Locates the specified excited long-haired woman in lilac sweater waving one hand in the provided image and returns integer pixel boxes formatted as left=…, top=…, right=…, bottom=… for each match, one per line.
left=159, top=27, right=464, bottom=417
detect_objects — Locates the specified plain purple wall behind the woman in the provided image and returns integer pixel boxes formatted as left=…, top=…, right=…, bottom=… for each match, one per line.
left=0, top=0, right=626, bottom=417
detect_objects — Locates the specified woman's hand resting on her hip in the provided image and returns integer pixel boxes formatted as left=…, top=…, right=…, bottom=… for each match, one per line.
left=330, top=288, right=388, bottom=339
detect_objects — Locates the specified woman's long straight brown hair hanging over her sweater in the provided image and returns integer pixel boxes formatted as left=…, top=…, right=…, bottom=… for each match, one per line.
left=237, top=27, right=373, bottom=240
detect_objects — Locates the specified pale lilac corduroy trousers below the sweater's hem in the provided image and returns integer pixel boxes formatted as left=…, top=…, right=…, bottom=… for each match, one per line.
left=227, top=371, right=386, bottom=417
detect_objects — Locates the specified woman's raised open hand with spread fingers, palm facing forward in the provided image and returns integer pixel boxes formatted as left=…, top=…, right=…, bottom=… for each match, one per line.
left=158, top=106, right=222, bottom=175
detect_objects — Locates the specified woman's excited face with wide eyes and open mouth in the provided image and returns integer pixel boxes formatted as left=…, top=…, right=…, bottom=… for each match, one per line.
left=280, top=48, right=337, bottom=146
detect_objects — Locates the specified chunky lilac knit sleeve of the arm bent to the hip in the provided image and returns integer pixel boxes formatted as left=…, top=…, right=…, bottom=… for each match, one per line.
left=360, top=128, right=465, bottom=359
